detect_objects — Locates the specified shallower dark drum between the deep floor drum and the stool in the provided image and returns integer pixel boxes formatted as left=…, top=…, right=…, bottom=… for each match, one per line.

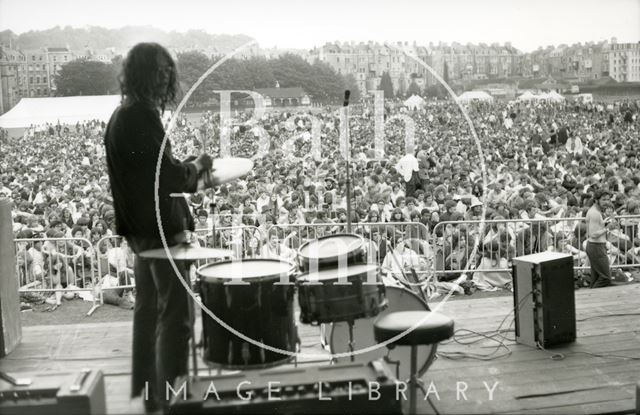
left=297, top=264, right=386, bottom=325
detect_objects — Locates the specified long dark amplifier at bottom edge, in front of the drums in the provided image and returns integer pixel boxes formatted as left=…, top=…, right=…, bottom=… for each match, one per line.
left=170, top=360, right=404, bottom=414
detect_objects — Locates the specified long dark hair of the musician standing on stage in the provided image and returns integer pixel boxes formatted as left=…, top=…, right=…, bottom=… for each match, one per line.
left=119, top=43, right=178, bottom=111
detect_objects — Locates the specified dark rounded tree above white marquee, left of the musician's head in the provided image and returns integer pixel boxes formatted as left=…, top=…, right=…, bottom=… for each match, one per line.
left=55, top=59, right=119, bottom=97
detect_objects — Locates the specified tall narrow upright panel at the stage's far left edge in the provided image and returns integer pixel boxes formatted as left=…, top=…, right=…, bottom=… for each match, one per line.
left=0, top=198, right=22, bottom=357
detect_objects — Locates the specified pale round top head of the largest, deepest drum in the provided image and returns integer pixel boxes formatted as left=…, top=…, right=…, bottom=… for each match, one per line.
left=198, top=258, right=295, bottom=282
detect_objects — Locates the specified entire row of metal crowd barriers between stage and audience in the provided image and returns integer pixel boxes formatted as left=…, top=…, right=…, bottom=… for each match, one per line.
left=14, top=215, right=640, bottom=314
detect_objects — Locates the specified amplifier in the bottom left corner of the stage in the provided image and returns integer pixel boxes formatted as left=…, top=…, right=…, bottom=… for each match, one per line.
left=0, top=369, right=107, bottom=415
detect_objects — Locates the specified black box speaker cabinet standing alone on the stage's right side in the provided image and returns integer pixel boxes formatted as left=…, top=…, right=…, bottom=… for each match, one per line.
left=512, top=252, right=576, bottom=348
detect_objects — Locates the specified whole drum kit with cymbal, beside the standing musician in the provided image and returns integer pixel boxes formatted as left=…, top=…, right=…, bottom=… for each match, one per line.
left=141, top=158, right=429, bottom=379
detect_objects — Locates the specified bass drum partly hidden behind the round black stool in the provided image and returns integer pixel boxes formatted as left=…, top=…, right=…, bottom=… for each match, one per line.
left=330, top=285, right=431, bottom=381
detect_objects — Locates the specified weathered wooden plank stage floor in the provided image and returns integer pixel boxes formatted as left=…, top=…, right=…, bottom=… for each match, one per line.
left=0, top=284, right=640, bottom=414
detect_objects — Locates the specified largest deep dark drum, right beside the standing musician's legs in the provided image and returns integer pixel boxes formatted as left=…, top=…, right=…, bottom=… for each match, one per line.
left=198, top=259, right=299, bottom=369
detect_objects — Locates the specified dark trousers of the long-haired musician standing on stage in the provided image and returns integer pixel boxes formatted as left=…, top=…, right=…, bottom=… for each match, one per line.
left=131, top=255, right=191, bottom=407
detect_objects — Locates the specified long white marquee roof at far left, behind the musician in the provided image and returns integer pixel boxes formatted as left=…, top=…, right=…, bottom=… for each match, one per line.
left=0, top=95, right=120, bottom=128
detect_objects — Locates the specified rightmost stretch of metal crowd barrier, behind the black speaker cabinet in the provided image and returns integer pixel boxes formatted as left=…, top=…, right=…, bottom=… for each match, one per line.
left=433, top=215, right=640, bottom=278
